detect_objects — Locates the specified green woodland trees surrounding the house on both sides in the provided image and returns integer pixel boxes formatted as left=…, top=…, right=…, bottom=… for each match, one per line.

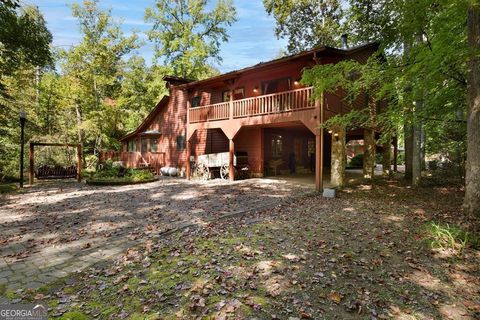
left=0, top=0, right=480, bottom=216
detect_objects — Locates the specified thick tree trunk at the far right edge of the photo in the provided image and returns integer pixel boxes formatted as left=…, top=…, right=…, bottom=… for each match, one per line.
left=463, top=0, right=480, bottom=217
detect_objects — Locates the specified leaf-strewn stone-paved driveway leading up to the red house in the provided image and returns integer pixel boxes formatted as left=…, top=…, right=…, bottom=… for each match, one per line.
left=0, top=178, right=313, bottom=294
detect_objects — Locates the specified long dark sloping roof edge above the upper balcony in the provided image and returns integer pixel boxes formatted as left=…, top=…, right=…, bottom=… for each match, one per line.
left=179, top=41, right=380, bottom=88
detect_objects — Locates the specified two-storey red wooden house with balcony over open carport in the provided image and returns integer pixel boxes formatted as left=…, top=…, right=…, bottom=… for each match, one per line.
left=111, top=42, right=378, bottom=190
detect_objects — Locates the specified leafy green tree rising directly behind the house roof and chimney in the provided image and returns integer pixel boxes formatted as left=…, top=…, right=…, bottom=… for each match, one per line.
left=145, top=0, right=236, bottom=79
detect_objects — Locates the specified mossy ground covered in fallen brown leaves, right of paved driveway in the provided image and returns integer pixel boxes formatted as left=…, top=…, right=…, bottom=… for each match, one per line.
left=10, top=181, right=480, bottom=319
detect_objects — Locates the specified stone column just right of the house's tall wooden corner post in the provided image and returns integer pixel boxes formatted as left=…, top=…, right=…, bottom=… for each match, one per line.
left=330, top=126, right=346, bottom=188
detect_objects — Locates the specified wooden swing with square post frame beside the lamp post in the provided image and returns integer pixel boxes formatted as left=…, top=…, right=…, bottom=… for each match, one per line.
left=29, top=142, right=81, bottom=184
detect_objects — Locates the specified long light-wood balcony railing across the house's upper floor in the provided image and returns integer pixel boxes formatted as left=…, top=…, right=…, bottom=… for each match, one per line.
left=189, top=87, right=315, bottom=123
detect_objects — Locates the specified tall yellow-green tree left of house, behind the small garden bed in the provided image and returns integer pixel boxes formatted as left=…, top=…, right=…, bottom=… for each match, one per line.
left=61, top=0, right=137, bottom=156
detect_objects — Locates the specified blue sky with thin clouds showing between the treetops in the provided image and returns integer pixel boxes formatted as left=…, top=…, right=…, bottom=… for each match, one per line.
left=32, top=0, right=286, bottom=73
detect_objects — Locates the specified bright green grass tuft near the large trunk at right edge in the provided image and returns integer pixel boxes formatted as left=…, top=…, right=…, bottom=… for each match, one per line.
left=424, top=222, right=479, bottom=254
